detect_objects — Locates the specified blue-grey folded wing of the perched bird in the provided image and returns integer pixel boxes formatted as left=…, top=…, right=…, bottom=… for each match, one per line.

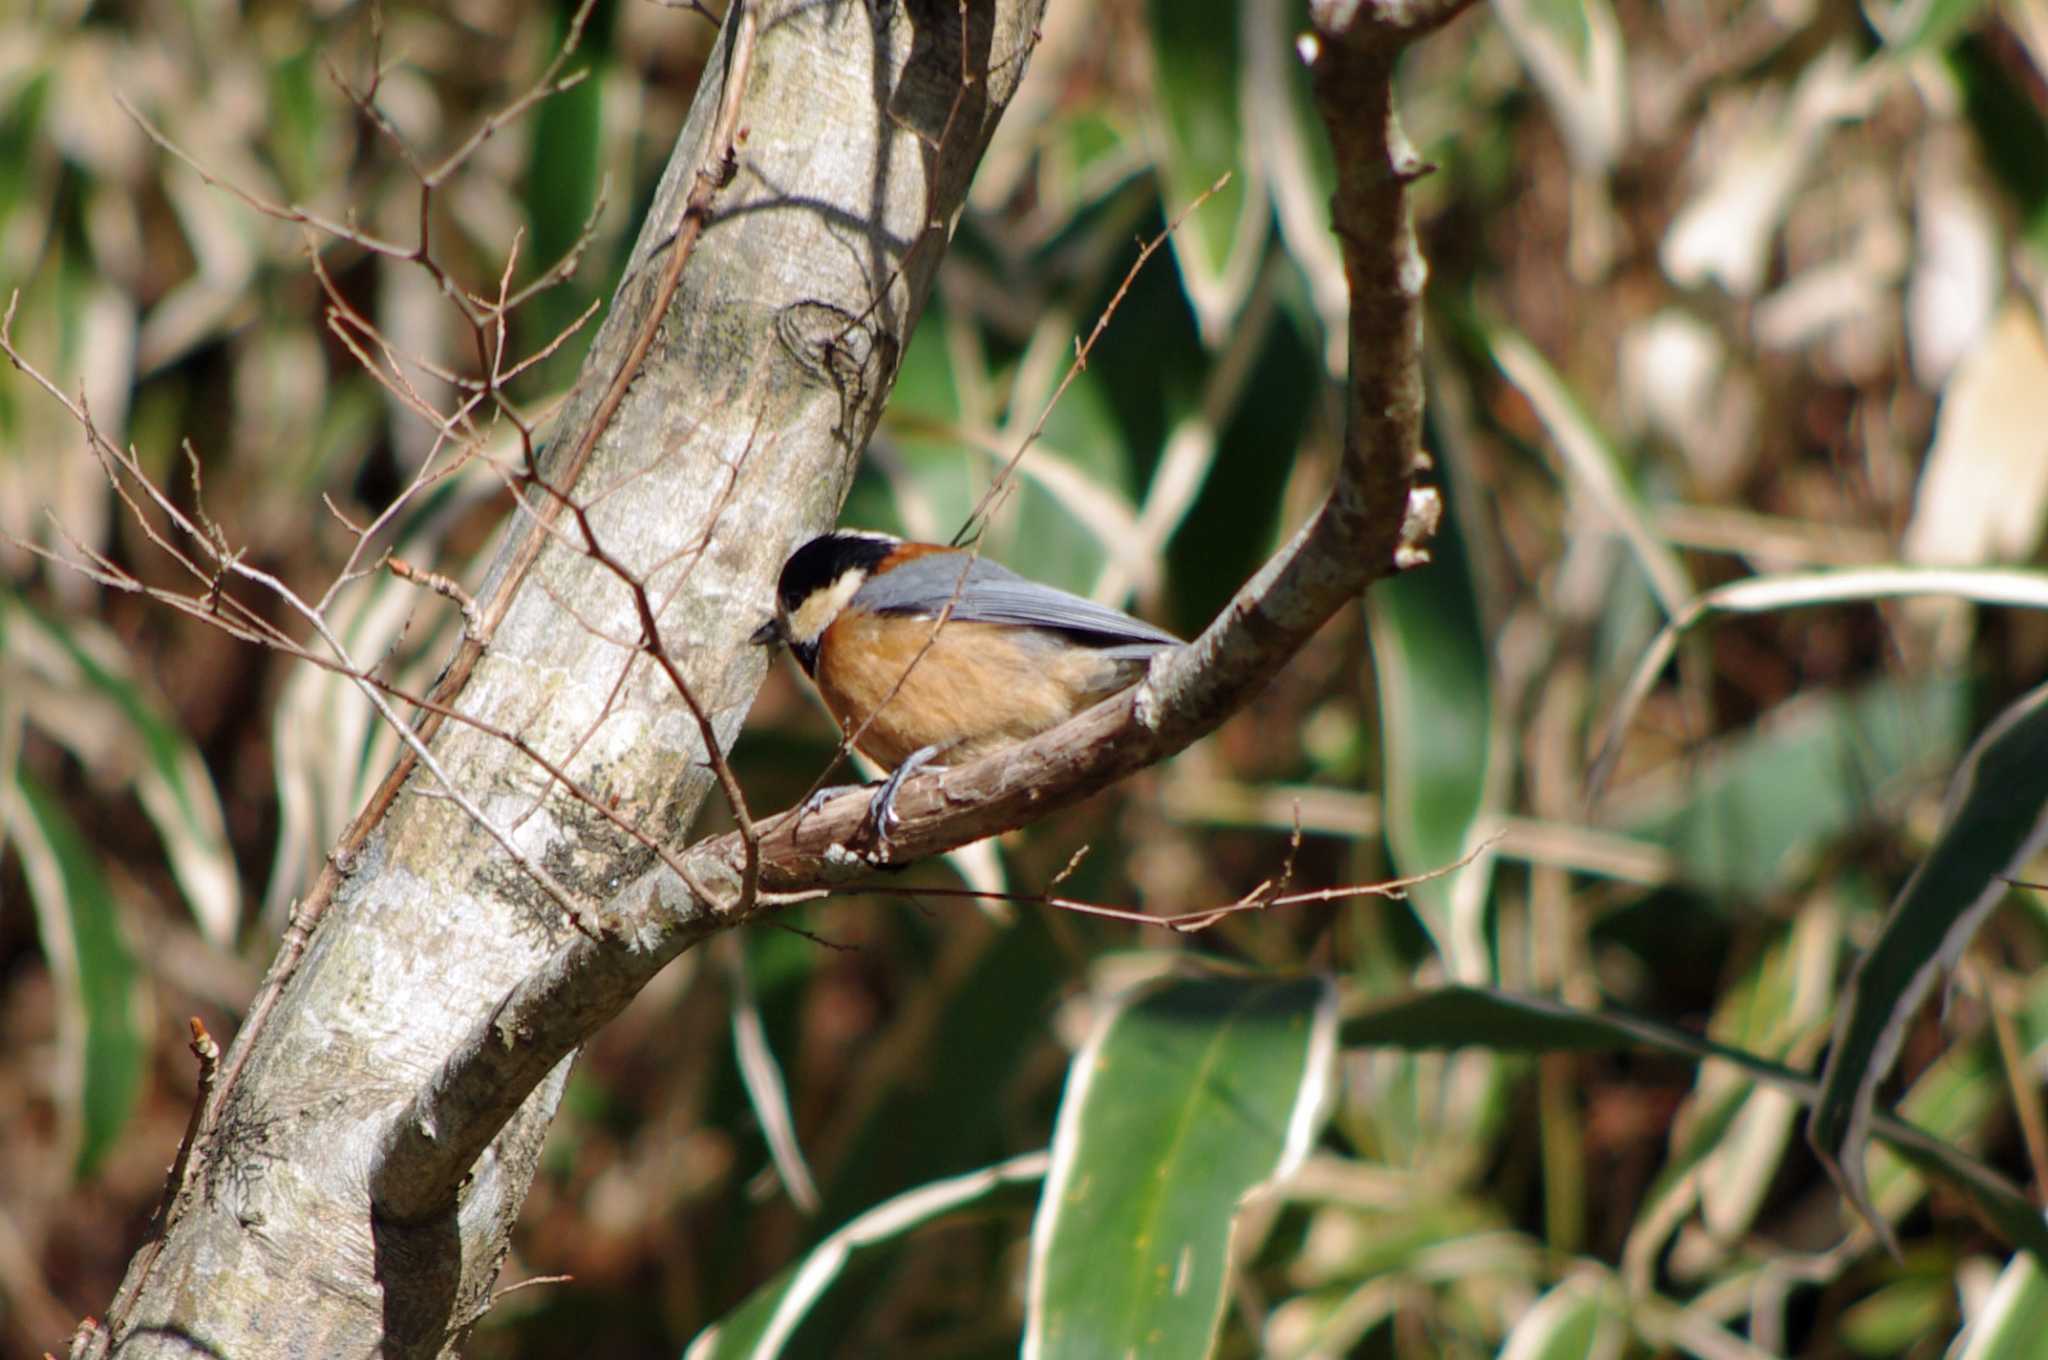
left=852, top=553, right=1180, bottom=660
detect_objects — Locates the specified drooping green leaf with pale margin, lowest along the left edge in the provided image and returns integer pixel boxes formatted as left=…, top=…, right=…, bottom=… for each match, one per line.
left=0, top=766, right=147, bottom=1180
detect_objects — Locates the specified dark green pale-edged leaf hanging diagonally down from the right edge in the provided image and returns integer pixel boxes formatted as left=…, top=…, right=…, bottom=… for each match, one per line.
left=1806, top=684, right=2048, bottom=1237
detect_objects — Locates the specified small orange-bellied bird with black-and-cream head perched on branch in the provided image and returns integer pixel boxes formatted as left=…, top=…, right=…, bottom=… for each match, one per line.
left=754, top=528, right=1180, bottom=842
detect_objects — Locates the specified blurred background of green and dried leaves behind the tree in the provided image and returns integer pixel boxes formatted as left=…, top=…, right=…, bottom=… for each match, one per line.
left=0, top=0, right=2048, bottom=1360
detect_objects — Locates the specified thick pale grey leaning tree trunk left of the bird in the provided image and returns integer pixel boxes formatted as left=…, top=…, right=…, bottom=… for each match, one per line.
left=98, top=0, right=1042, bottom=1356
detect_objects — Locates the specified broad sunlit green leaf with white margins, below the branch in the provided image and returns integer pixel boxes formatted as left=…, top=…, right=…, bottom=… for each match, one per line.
left=1022, top=977, right=1335, bottom=1360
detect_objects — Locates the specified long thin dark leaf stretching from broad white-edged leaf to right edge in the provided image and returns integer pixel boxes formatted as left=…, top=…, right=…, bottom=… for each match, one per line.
left=1341, top=987, right=2048, bottom=1260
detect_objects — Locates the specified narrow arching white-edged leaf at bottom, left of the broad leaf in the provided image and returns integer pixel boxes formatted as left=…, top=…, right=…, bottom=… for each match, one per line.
left=682, top=1151, right=1049, bottom=1360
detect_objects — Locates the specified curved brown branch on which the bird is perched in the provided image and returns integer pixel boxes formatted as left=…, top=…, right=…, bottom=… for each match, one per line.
left=373, top=0, right=1468, bottom=1215
